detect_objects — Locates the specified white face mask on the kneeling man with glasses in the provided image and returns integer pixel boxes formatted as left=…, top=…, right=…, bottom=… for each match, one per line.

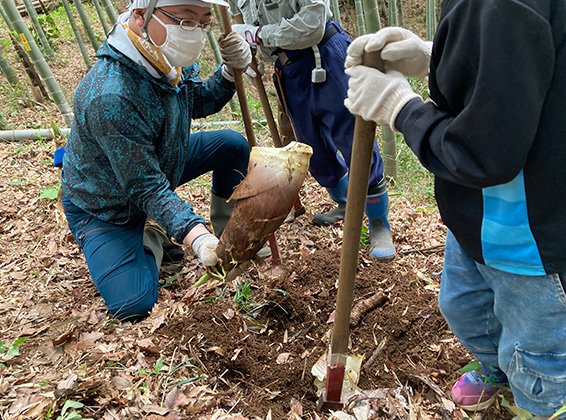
left=153, top=15, right=204, bottom=67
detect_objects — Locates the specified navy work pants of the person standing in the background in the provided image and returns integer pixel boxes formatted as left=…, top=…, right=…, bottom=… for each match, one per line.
left=275, top=21, right=383, bottom=188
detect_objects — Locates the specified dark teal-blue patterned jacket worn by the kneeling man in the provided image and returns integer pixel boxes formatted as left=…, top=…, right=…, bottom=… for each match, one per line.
left=62, top=42, right=235, bottom=242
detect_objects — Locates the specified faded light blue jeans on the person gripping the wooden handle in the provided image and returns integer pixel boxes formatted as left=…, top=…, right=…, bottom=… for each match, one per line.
left=439, top=231, right=566, bottom=418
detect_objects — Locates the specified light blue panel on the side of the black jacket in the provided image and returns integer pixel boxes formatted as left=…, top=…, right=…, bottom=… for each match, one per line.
left=481, top=171, right=546, bottom=276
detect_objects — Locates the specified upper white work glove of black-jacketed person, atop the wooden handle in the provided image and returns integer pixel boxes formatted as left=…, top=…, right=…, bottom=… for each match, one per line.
left=345, top=26, right=432, bottom=77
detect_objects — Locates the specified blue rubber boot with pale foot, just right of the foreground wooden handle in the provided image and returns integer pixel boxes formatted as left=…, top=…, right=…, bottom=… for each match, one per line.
left=366, top=179, right=395, bottom=262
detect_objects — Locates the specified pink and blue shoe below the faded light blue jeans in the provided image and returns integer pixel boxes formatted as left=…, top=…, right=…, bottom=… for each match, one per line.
left=451, top=371, right=503, bottom=411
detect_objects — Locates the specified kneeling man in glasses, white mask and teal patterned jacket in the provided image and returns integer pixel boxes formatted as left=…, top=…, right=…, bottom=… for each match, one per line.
left=62, top=0, right=251, bottom=320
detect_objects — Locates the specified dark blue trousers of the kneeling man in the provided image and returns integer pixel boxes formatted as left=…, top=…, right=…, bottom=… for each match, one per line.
left=63, top=130, right=249, bottom=320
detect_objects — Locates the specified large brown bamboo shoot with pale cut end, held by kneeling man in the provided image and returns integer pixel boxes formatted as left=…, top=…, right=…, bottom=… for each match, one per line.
left=216, top=142, right=312, bottom=271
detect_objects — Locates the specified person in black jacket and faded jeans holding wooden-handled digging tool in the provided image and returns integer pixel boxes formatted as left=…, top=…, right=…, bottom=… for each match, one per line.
left=345, top=0, right=566, bottom=416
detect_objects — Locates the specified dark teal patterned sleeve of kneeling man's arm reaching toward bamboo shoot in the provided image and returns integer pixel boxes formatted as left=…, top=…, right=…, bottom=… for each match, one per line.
left=85, top=94, right=204, bottom=243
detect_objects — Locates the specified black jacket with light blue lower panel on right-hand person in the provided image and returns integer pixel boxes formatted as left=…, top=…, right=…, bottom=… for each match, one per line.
left=396, top=0, right=566, bottom=275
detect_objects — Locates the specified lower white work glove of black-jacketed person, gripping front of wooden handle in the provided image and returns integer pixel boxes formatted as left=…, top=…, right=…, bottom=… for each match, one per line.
left=344, top=66, right=420, bottom=130
